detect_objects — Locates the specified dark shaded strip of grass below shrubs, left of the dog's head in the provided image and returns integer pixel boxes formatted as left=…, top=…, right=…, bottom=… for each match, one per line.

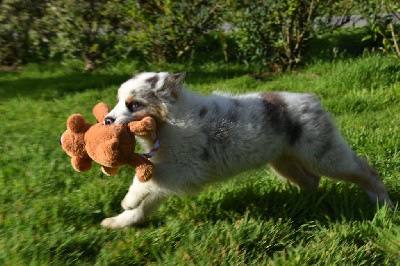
left=0, top=73, right=128, bottom=101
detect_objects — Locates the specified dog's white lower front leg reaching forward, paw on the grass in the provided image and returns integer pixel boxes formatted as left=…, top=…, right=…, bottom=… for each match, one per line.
left=101, top=193, right=166, bottom=229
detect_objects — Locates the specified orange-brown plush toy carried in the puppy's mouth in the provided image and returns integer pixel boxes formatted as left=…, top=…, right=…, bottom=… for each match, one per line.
left=61, top=103, right=158, bottom=182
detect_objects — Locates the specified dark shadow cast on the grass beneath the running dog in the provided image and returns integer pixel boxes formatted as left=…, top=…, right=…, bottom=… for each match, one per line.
left=158, top=184, right=399, bottom=226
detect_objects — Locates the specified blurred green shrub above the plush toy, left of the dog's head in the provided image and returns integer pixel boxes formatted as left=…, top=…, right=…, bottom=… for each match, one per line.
left=47, top=0, right=126, bottom=71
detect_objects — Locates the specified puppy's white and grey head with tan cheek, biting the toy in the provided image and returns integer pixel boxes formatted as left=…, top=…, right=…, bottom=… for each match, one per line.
left=104, top=72, right=185, bottom=124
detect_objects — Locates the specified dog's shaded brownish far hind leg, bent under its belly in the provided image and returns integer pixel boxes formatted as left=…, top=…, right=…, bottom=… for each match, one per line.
left=270, top=155, right=321, bottom=189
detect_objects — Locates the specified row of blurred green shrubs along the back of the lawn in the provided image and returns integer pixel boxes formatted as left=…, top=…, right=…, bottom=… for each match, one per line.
left=0, top=0, right=400, bottom=71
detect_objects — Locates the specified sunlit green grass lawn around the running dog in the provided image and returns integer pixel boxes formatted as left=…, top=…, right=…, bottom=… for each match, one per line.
left=0, top=56, right=400, bottom=265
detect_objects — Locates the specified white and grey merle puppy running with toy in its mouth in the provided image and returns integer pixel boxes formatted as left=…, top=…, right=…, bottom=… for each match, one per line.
left=101, top=72, right=393, bottom=228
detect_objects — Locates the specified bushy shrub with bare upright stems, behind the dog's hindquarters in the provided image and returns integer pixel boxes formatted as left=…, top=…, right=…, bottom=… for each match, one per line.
left=234, top=0, right=348, bottom=71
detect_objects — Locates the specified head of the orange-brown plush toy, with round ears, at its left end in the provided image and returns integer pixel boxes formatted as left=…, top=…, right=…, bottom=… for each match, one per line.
left=60, top=114, right=92, bottom=172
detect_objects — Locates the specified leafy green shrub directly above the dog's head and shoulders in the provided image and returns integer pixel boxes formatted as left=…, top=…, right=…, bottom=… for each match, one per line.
left=120, top=0, right=222, bottom=63
